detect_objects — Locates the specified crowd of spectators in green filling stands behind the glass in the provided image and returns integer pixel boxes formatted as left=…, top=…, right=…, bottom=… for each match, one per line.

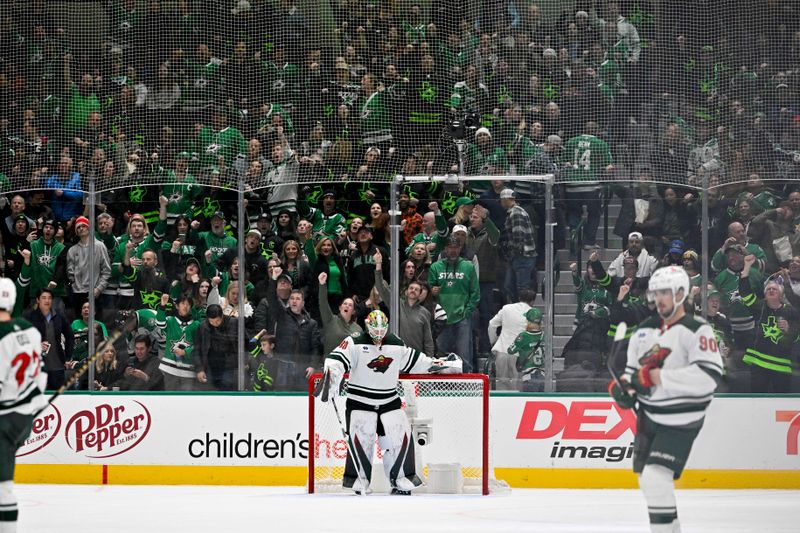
left=0, top=0, right=800, bottom=392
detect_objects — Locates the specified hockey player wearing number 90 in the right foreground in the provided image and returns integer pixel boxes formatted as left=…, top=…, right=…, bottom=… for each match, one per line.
left=609, top=266, right=722, bottom=533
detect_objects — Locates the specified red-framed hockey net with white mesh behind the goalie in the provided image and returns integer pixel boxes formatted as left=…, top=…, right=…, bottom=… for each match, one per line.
left=308, top=374, right=507, bottom=495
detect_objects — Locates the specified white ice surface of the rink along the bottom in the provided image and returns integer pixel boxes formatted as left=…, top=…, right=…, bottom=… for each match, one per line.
left=15, top=485, right=800, bottom=533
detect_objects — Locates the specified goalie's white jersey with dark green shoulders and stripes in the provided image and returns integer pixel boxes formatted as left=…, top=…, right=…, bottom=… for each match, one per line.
left=325, top=333, right=433, bottom=405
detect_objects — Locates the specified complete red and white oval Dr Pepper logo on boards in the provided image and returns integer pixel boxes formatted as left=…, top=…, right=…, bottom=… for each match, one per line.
left=64, top=401, right=151, bottom=458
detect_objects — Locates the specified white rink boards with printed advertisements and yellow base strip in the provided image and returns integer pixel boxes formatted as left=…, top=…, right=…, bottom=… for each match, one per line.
left=17, top=394, right=800, bottom=488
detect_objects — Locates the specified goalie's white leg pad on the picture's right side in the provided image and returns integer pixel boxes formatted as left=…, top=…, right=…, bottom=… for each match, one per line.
left=379, top=409, right=422, bottom=491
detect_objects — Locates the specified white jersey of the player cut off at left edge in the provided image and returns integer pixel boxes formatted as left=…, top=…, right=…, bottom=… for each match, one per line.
left=0, top=318, right=47, bottom=415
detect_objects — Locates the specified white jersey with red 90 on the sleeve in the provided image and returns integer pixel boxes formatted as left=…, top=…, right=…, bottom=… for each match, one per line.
left=625, top=315, right=722, bottom=426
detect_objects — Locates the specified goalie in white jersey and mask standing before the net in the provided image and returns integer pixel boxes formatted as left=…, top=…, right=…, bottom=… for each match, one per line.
left=322, top=311, right=462, bottom=495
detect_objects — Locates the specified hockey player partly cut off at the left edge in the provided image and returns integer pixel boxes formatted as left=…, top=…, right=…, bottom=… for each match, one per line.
left=0, top=278, right=47, bottom=533
